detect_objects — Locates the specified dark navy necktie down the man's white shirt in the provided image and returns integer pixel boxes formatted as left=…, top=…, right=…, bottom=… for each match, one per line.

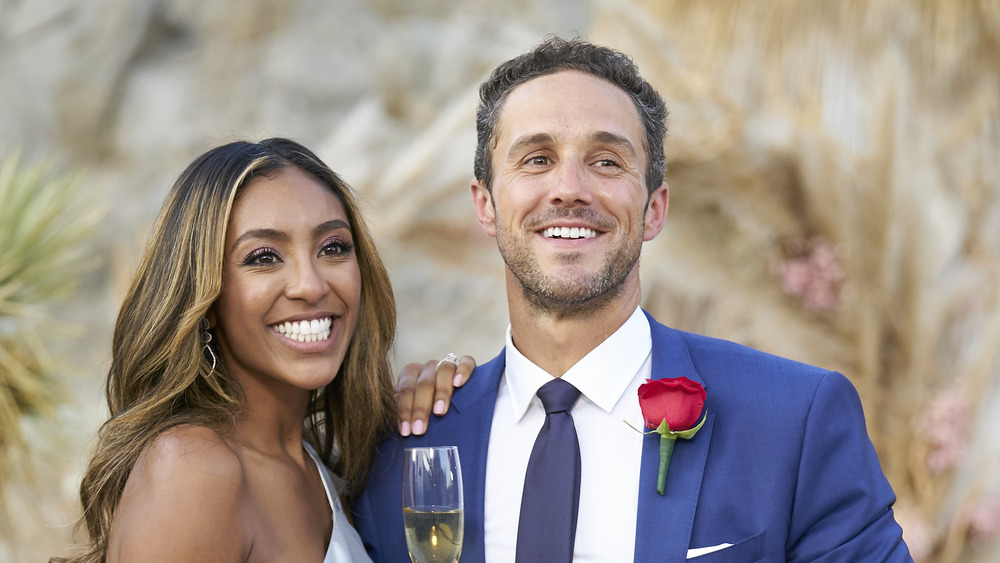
left=516, top=378, right=580, bottom=563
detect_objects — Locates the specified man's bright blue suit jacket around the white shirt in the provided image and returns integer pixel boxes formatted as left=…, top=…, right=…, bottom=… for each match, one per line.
left=353, top=313, right=911, bottom=563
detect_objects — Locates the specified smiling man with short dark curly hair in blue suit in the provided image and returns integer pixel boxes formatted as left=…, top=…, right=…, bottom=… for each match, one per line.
left=355, top=38, right=910, bottom=563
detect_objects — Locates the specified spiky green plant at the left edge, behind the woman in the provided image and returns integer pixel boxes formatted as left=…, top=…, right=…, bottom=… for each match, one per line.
left=0, top=151, right=98, bottom=506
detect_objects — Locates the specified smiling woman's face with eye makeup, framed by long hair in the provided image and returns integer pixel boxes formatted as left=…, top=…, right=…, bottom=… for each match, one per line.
left=209, top=167, right=361, bottom=400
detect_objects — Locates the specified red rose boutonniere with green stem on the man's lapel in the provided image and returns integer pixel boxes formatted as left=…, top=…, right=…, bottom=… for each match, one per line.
left=639, top=377, right=707, bottom=495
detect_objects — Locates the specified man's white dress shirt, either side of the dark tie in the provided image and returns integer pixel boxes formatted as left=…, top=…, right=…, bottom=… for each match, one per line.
left=484, top=307, right=652, bottom=563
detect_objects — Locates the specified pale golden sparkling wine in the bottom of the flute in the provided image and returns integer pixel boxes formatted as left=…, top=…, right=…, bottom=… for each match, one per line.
left=403, top=508, right=465, bottom=563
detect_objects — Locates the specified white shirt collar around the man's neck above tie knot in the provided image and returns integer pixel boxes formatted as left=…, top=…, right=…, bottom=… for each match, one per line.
left=504, top=307, right=653, bottom=420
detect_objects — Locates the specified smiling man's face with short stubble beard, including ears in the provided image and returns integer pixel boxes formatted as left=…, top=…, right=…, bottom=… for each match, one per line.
left=472, top=71, right=667, bottom=315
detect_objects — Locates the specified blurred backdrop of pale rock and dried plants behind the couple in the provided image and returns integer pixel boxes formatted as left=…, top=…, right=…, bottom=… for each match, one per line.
left=0, top=0, right=1000, bottom=561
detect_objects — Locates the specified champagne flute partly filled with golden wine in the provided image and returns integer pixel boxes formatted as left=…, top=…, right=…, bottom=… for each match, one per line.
left=403, top=446, right=465, bottom=563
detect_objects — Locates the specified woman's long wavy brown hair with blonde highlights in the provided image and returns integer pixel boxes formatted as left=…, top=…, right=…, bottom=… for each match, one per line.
left=56, top=138, right=396, bottom=562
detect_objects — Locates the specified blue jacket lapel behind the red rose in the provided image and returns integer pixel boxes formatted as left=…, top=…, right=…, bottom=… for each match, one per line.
left=635, top=313, right=715, bottom=562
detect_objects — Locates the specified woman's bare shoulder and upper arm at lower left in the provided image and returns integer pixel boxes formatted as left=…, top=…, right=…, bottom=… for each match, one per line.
left=108, top=425, right=250, bottom=561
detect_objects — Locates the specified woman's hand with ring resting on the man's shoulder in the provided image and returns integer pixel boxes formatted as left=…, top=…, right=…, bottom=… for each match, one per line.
left=396, top=354, right=476, bottom=436
